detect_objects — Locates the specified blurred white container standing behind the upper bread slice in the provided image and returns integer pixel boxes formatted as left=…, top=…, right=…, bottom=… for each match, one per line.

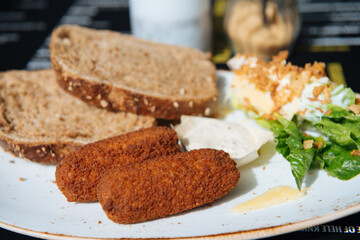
left=130, top=0, right=211, bottom=51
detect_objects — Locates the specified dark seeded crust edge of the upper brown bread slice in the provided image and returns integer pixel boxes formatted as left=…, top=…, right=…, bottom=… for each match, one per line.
left=50, top=24, right=217, bottom=120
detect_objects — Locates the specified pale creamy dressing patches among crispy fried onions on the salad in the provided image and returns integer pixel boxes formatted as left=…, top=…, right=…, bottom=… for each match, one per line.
left=231, top=57, right=351, bottom=122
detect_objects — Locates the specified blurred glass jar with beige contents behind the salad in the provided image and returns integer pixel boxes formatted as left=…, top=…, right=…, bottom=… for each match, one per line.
left=224, top=0, right=300, bottom=60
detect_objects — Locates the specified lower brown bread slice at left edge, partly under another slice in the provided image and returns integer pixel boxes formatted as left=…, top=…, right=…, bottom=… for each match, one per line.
left=0, top=70, right=156, bottom=164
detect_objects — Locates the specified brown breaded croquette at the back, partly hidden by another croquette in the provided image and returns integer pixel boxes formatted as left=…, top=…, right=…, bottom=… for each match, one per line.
left=55, top=127, right=180, bottom=202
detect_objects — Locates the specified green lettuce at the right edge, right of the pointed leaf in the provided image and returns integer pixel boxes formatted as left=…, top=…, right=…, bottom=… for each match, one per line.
left=300, top=103, right=360, bottom=180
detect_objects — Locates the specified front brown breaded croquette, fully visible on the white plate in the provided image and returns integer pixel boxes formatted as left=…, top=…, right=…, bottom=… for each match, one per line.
left=97, top=149, right=240, bottom=224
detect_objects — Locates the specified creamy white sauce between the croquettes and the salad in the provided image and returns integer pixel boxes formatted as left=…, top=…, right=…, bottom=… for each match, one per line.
left=175, top=115, right=271, bottom=167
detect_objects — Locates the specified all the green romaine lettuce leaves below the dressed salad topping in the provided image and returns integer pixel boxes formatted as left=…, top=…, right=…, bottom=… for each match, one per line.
left=259, top=105, right=360, bottom=189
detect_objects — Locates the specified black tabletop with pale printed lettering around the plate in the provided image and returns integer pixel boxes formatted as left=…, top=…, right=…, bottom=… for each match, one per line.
left=0, top=0, right=360, bottom=240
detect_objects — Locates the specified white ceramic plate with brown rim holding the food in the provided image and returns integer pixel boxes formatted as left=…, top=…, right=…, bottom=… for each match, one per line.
left=0, top=71, right=360, bottom=239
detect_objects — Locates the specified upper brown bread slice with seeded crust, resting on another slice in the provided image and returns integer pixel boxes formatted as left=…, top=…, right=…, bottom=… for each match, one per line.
left=50, top=25, right=217, bottom=120
